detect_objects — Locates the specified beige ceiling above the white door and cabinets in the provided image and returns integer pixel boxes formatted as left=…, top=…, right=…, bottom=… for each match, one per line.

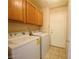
left=32, top=0, right=68, bottom=8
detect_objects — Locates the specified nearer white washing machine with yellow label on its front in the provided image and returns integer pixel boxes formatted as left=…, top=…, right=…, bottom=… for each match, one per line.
left=8, top=33, right=40, bottom=59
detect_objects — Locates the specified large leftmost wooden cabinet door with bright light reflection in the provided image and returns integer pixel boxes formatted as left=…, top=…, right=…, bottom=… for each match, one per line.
left=8, top=0, right=24, bottom=22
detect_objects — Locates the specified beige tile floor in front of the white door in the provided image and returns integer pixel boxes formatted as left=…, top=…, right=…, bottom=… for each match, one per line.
left=45, top=46, right=67, bottom=59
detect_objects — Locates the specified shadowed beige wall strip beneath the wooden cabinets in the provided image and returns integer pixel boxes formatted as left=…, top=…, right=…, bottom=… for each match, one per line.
left=8, top=21, right=40, bottom=32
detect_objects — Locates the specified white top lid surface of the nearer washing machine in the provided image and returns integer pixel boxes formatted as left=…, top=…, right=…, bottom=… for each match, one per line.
left=9, top=36, right=40, bottom=49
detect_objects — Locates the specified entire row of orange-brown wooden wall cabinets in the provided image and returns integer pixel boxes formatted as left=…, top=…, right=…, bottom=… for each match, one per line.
left=8, top=0, right=43, bottom=26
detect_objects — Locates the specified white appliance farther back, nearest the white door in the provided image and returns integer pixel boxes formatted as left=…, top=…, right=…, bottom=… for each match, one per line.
left=32, top=32, right=49, bottom=59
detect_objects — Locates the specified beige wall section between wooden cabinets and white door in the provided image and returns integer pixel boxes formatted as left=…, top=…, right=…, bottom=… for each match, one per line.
left=41, top=7, right=50, bottom=33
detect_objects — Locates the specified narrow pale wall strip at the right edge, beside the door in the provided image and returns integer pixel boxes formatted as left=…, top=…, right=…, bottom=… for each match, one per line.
left=67, top=0, right=71, bottom=59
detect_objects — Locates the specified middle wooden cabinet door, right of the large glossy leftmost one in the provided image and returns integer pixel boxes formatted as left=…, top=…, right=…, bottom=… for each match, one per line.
left=27, top=2, right=35, bottom=24
